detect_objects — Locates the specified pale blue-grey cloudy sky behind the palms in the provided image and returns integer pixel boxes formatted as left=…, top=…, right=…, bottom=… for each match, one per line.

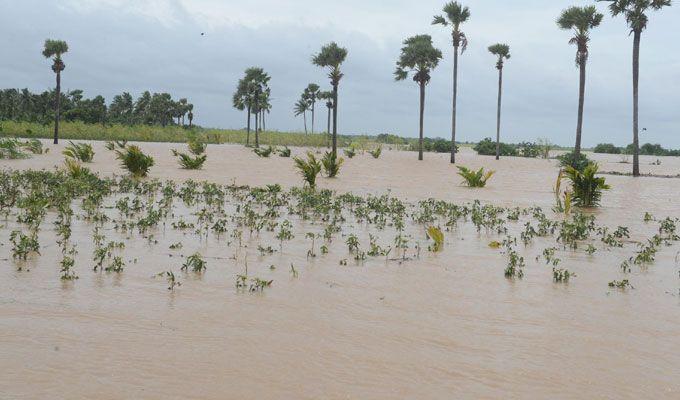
left=0, top=0, right=680, bottom=147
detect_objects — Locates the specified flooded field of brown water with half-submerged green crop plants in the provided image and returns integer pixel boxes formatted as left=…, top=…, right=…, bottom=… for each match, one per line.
left=0, top=139, right=680, bottom=399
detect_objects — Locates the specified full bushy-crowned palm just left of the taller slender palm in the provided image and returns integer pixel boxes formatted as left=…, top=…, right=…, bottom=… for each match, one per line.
left=394, top=35, right=442, bottom=161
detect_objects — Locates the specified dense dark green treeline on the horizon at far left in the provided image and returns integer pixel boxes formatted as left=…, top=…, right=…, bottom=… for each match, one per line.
left=0, top=89, right=194, bottom=126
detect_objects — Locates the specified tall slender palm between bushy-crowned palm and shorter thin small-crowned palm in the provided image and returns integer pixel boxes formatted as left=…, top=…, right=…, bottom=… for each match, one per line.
left=432, top=1, right=470, bottom=164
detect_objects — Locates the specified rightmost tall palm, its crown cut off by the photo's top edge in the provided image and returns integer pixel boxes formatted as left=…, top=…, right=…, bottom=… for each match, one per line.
left=597, top=0, right=671, bottom=176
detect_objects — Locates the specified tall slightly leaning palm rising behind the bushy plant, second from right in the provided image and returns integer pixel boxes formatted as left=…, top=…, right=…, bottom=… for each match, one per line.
left=557, top=6, right=604, bottom=160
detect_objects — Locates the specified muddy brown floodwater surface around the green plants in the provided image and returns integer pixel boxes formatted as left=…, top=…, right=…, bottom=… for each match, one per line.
left=0, top=143, right=680, bottom=399
